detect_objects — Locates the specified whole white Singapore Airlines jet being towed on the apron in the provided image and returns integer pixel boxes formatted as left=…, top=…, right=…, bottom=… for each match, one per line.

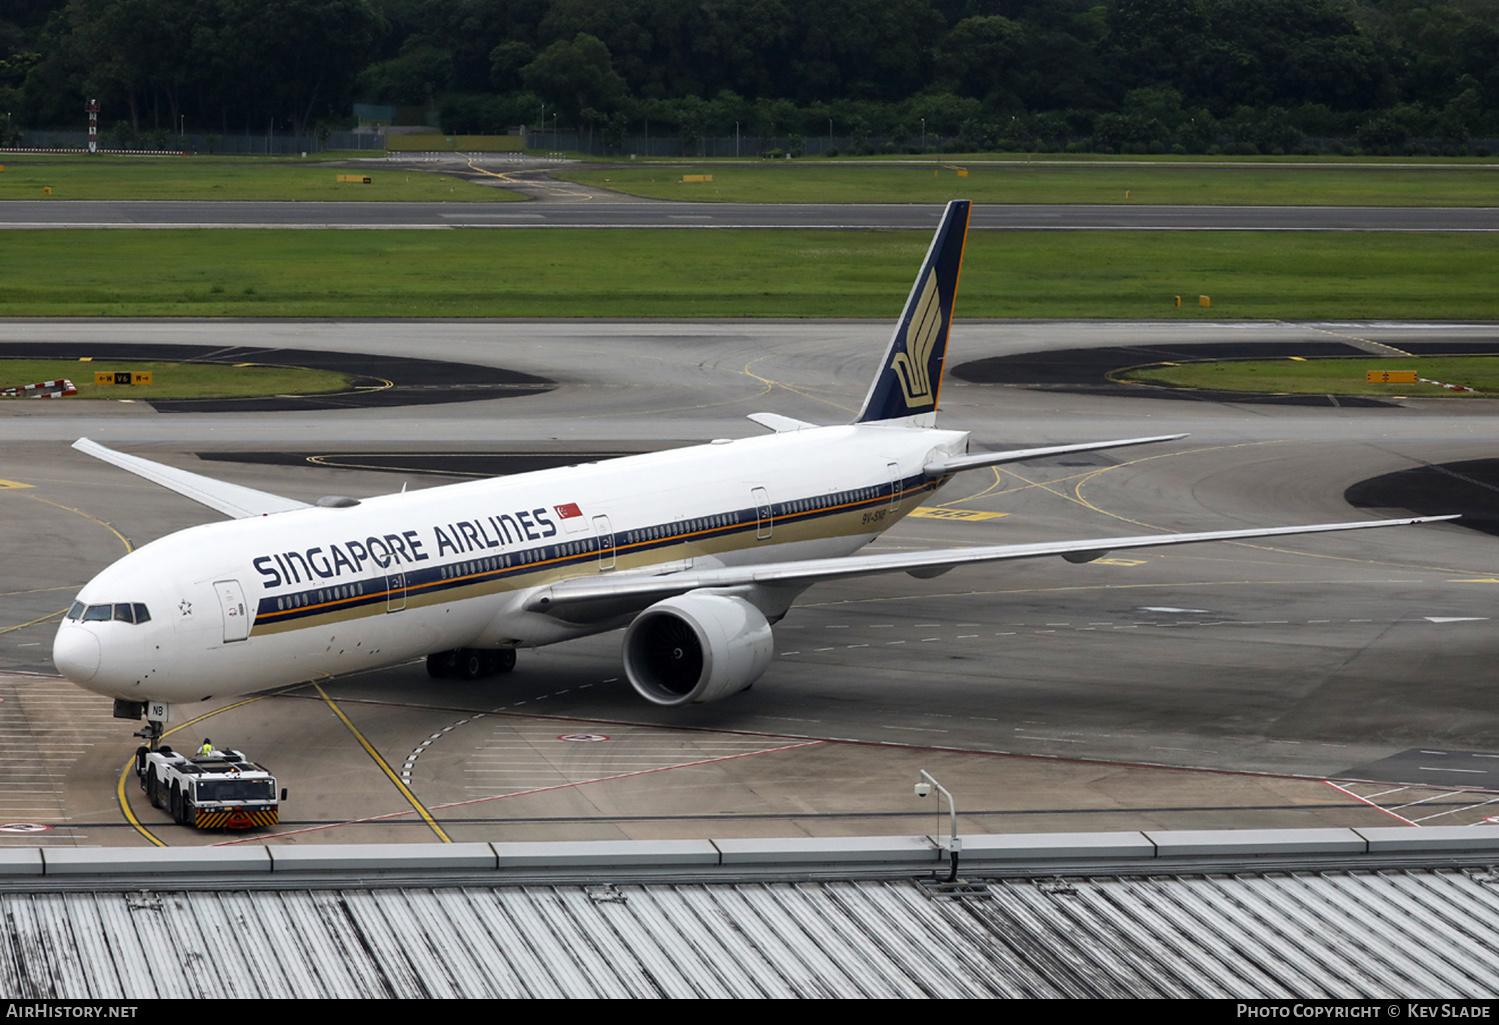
left=52, top=201, right=1444, bottom=742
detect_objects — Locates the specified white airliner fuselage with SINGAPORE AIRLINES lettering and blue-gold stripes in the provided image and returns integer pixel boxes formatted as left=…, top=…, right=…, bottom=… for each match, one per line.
left=54, top=424, right=967, bottom=703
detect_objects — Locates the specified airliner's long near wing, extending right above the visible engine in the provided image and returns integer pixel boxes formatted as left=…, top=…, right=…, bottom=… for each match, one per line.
left=526, top=515, right=1457, bottom=622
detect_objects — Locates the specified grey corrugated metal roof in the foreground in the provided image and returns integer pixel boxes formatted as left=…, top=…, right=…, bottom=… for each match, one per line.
left=0, top=868, right=1499, bottom=1000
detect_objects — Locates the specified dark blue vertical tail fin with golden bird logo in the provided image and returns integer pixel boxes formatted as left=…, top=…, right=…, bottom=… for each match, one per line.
left=854, top=199, right=971, bottom=427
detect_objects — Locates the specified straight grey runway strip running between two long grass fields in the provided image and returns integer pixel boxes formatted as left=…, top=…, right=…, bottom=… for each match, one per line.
left=0, top=197, right=1499, bottom=232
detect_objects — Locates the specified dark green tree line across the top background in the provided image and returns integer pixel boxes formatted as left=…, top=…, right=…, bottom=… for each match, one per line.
left=0, top=0, right=1499, bottom=153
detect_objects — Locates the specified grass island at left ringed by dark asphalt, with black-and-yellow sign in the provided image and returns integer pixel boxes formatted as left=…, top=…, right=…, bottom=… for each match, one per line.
left=0, top=360, right=349, bottom=402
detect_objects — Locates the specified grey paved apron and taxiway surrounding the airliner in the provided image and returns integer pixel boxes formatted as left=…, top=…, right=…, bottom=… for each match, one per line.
left=0, top=321, right=1499, bottom=844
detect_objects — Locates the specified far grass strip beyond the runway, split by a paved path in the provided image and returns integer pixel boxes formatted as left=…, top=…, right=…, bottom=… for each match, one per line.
left=0, top=153, right=1499, bottom=207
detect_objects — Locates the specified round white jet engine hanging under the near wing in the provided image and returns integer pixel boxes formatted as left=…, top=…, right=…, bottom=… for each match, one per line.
left=625, top=593, right=775, bottom=706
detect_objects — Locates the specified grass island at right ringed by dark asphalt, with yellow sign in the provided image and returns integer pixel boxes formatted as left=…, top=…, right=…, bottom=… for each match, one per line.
left=1114, top=357, right=1499, bottom=396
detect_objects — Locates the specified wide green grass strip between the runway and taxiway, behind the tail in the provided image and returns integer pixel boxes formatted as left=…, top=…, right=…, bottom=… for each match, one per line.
left=0, top=229, right=1499, bottom=319
